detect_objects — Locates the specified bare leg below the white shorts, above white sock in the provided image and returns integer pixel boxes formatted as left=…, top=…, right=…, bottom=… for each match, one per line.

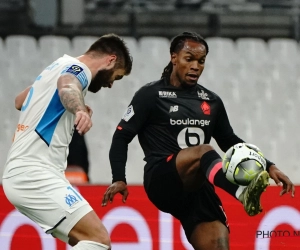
left=69, top=210, right=110, bottom=246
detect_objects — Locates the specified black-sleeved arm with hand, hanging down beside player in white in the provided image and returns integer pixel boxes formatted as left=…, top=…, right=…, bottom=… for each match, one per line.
left=102, top=85, right=157, bottom=206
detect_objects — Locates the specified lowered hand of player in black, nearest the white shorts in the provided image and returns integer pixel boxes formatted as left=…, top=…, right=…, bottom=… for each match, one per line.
left=101, top=181, right=129, bottom=207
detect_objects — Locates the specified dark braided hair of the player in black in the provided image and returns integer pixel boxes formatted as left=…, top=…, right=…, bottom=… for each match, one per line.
left=161, top=32, right=208, bottom=78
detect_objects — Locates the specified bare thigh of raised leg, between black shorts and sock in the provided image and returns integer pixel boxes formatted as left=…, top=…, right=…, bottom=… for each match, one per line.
left=176, top=144, right=213, bottom=187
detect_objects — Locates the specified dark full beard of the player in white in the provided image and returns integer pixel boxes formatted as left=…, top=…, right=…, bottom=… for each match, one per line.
left=88, top=69, right=114, bottom=93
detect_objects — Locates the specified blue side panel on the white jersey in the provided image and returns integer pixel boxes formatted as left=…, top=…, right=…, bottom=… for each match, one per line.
left=35, top=90, right=65, bottom=146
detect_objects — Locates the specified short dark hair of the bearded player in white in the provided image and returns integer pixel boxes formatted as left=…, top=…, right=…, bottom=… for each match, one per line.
left=86, top=33, right=132, bottom=75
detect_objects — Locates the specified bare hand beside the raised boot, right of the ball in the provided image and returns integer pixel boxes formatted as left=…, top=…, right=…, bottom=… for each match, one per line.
left=269, top=165, right=295, bottom=197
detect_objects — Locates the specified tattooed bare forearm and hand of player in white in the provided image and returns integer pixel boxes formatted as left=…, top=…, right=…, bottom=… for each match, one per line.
left=57, top=74, right=92, bottom=135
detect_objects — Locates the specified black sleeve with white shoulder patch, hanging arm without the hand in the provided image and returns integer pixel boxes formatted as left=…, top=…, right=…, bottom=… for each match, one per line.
left=109, top=86, right=155, bottom=183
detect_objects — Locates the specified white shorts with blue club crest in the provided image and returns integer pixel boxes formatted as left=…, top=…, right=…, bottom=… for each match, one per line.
left=2, top=167, right=93, bottom=243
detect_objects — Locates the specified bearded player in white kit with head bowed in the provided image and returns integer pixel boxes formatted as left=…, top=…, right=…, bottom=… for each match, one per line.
left=2, top=34, right=132, bottom=250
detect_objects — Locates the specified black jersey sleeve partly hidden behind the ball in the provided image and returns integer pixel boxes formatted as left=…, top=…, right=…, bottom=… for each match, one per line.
left=213, top=96, right=275, bottom=172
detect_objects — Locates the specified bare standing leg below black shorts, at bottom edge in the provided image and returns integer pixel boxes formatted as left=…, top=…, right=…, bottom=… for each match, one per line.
left=190, top=220, right=229, bottom=250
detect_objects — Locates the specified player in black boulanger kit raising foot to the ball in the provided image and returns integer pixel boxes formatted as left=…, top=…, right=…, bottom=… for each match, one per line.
left=102, top=32, right=294, bottom=250
